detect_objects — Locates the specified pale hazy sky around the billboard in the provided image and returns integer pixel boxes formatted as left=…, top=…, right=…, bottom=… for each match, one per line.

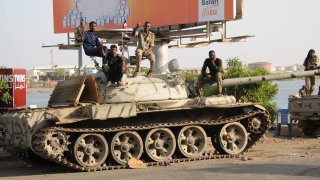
left=0, top=0, right=320, bottom=69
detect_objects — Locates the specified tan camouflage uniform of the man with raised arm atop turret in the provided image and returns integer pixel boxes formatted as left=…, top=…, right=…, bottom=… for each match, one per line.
left=135, top=30, right=156, bottom=72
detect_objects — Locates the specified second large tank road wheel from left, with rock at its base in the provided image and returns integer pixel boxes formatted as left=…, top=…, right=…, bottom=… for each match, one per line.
left=111, top=131, right=143, bottom=164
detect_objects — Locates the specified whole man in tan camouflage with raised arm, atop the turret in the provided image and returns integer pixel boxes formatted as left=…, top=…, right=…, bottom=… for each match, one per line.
left=132, top=22, right=155, bottom=77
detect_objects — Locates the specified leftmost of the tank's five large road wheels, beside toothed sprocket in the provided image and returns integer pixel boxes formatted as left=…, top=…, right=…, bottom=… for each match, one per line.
left=74, top=134, right=108, bottom=167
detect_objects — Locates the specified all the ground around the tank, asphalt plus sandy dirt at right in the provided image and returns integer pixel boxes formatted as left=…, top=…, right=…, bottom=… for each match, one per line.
left=0, top=130, right=320, bottom=180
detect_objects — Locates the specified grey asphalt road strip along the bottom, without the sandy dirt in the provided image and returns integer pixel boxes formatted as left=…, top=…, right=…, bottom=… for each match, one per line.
left=0, top=150, right=320, bottom=180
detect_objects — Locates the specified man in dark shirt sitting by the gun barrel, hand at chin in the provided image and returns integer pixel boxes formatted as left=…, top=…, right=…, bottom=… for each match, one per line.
left=198, top=50, right=224, bottom=96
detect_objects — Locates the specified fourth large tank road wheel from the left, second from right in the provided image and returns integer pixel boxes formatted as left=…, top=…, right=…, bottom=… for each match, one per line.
left=178, top=126, right=207, bottom=158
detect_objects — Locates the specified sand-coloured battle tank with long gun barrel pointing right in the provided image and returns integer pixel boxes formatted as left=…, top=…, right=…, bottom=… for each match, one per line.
left=0, top=68, right=316, bottom=171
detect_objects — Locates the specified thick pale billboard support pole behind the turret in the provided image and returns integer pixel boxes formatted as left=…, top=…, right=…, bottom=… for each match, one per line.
left=154, top=40, right=169, bottom=74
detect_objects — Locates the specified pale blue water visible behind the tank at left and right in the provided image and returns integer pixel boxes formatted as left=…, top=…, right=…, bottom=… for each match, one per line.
left=27, top=80, right=320, bottom=108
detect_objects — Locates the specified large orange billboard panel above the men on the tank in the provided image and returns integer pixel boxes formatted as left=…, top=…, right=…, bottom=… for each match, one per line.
left=53, top=0, right=242, bottom=33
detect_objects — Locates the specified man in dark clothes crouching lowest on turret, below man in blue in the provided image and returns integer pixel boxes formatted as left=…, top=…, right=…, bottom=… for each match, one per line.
left=102, top=45, right=126, bottom=86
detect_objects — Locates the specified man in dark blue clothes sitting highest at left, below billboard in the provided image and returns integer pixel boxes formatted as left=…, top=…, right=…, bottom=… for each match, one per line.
left=82, top=21, right=108, bottom=57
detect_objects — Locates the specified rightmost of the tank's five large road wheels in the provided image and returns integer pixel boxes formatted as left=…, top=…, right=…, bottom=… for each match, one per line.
left=219, top=122, right=248, bottom=154
